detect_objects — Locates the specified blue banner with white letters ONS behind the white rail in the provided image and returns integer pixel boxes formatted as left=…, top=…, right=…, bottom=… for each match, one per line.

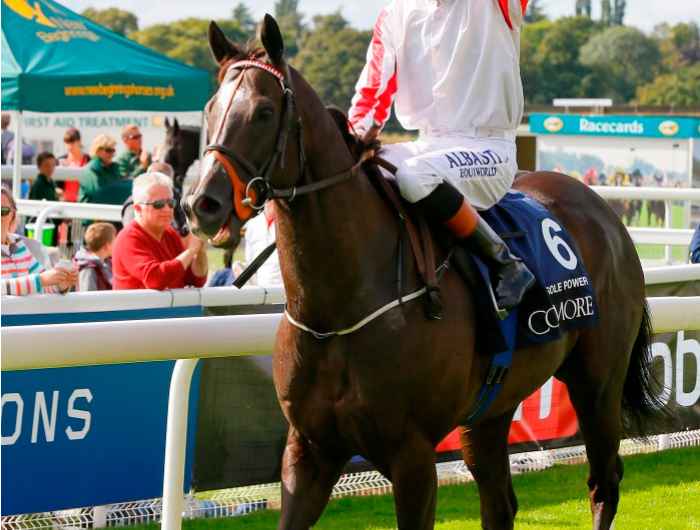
left=1, top=306, right=202, bottom=515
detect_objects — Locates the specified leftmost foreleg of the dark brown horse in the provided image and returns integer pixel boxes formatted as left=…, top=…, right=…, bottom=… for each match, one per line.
left=278, top=427, right=347, bottom=530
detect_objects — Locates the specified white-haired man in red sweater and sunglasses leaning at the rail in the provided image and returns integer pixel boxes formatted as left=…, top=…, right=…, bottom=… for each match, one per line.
left=112, top=173, right=208, bottom=289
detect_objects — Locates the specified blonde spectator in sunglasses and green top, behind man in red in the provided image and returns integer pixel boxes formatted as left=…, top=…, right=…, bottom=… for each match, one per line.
left=80, top=134, right=131, bottom=204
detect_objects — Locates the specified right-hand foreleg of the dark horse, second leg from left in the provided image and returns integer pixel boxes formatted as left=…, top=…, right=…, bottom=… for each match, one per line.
left=389, top=433, right=437, bottom=530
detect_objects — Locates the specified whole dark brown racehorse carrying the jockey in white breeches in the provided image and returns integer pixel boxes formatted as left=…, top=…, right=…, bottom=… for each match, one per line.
left=185, top=15, right=655, bottom=530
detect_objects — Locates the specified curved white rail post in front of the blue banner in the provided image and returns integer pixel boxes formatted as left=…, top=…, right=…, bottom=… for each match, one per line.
left=160, top=359, right=199, bottom=530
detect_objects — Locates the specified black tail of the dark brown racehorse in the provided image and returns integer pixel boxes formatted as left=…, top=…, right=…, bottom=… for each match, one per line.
left=622, top=301, right=664, bottom=436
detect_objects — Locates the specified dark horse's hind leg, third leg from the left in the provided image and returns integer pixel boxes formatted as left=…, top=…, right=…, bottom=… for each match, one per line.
left=461, top=411, right=518, bottom=530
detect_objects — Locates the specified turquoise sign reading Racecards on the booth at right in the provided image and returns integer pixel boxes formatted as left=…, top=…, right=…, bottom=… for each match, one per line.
left=530, top=114, right=700, bottom=139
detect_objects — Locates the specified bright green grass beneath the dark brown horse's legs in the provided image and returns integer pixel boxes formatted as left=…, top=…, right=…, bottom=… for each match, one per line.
left=132, top=447, right=700, bottom=530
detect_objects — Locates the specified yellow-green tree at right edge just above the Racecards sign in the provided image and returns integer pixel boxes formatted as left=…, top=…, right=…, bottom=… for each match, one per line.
left=636, top=63, right=700, bottom=108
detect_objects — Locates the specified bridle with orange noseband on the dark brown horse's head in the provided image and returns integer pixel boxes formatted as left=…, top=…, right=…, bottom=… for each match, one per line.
left=205, top=58, right=370, bottom=222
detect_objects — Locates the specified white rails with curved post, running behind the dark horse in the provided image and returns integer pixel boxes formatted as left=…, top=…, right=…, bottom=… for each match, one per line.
left=2, top=266, right=700, bottom=530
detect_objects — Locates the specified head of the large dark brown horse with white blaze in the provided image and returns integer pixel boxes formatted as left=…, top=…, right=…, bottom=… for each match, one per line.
left=184, top=15, right=299, bottom=247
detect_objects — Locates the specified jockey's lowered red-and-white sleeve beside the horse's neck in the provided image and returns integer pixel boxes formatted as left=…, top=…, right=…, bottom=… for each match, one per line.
left=348, top=9, right=397, bottom=135
